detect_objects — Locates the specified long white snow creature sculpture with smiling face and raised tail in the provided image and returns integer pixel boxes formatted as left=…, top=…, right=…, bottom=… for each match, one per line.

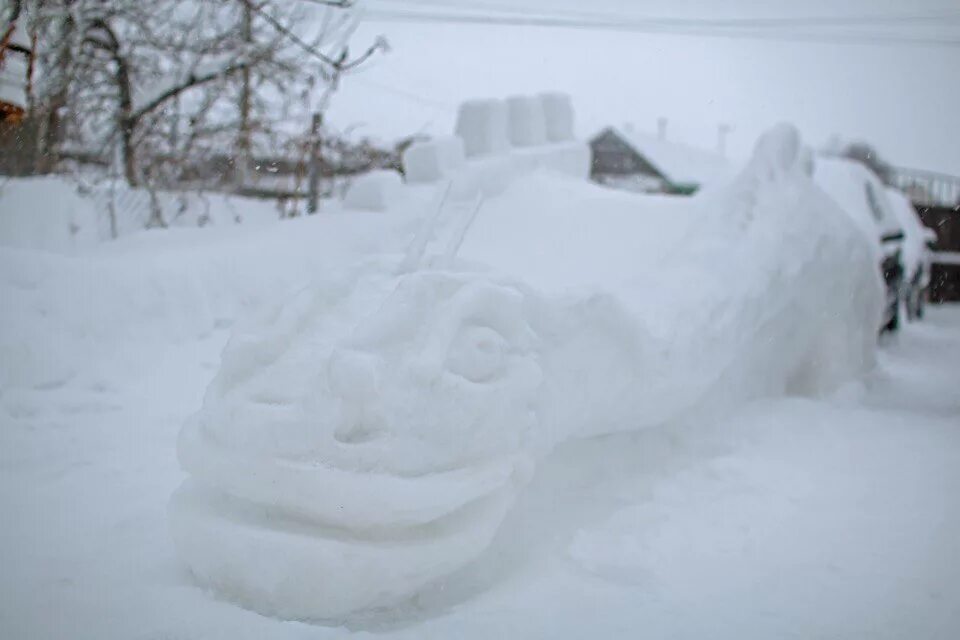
left=170, top=124, right=882, bottom=619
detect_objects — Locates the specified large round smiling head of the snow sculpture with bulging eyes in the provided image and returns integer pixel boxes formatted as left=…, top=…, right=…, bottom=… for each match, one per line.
left=171, top=260, right=542, bottom=618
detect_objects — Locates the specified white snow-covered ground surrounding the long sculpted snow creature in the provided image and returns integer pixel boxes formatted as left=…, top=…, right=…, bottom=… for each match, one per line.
left=0, top=182, right=960, bottom=639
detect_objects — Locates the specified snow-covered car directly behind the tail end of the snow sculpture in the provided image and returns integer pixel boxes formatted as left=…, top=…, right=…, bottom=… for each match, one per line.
left=814, top=156, right=905, bottom=331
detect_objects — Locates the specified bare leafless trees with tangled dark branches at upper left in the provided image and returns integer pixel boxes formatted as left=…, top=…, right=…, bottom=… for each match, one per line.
left=15, top=0, right=386, bottom=186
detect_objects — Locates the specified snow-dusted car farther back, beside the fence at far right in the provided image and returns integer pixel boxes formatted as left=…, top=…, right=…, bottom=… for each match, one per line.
left=887, top=188, right=937, bottom=320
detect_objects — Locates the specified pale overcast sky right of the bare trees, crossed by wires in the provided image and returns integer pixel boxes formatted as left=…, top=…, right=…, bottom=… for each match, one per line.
left=330, top=0, right=960, bottom=175
